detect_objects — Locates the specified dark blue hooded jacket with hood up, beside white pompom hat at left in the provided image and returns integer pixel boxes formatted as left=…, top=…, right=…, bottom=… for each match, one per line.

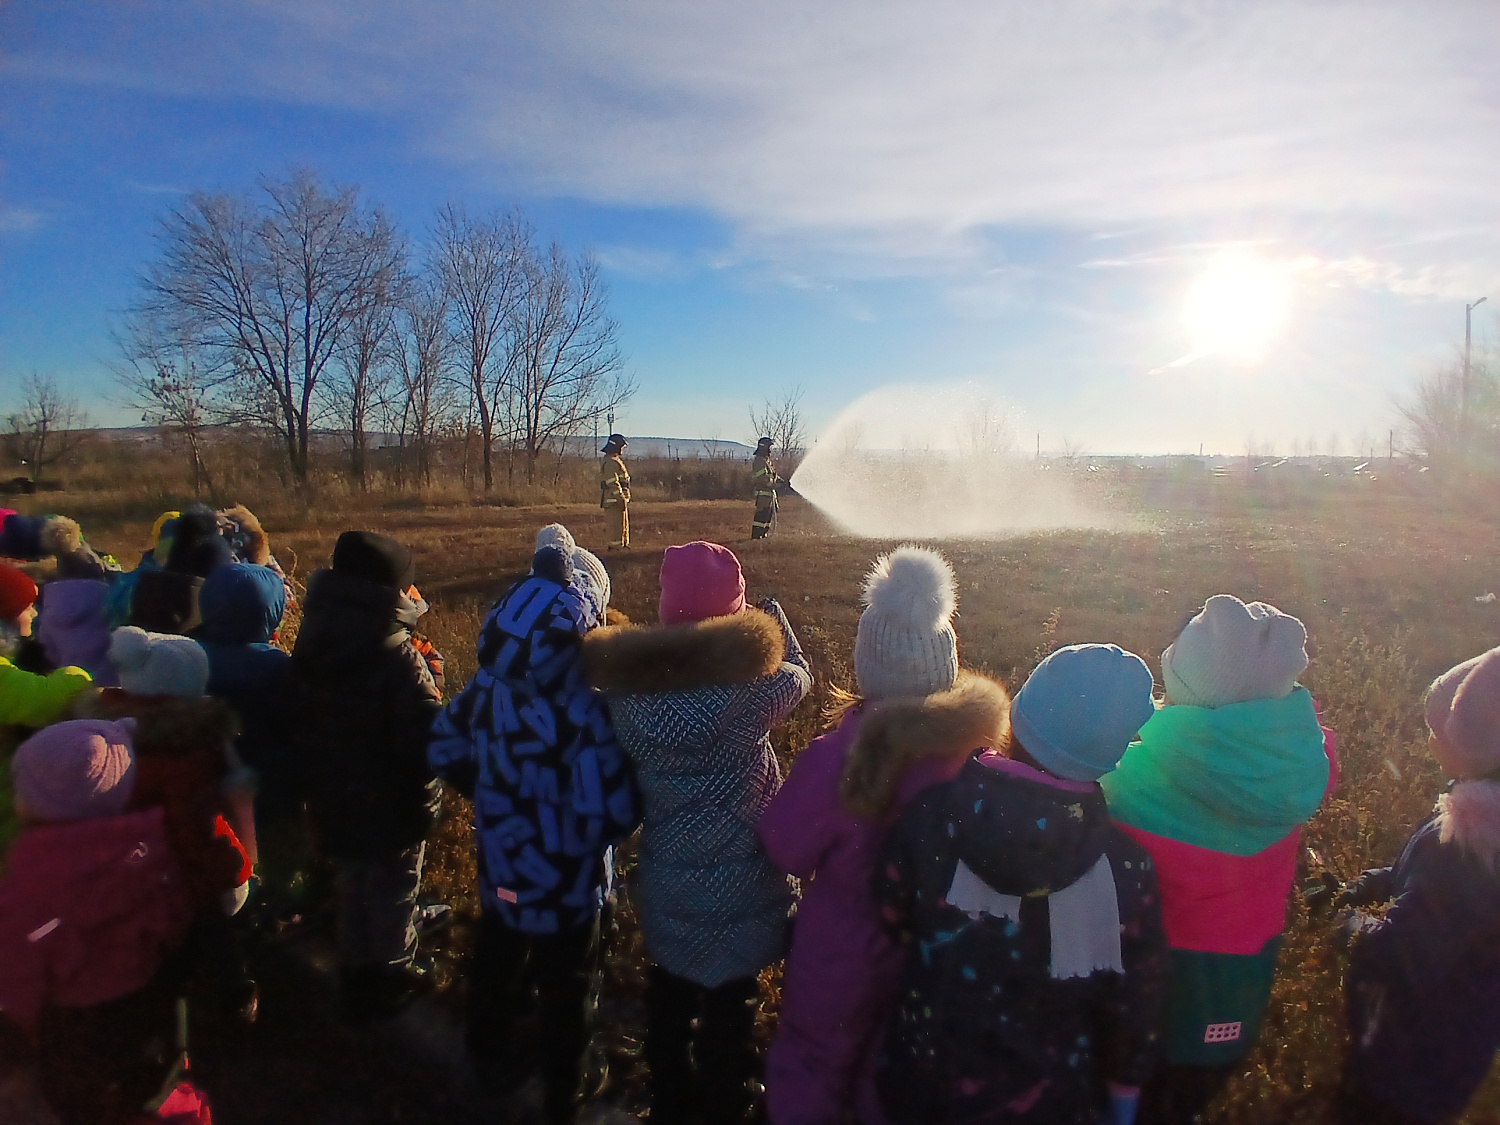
left=194, top=563, right=300, bottom=819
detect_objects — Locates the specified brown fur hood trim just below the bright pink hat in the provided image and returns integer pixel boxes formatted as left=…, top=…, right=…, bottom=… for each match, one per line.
left=584, top=609, right=786, bottom=695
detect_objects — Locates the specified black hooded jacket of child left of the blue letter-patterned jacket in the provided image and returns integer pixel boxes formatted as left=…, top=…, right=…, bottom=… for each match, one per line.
left=291, top=570, right=443, bottom=860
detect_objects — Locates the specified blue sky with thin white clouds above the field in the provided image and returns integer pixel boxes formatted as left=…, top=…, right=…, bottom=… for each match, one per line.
left=0, top=0, right=1500, bottom=453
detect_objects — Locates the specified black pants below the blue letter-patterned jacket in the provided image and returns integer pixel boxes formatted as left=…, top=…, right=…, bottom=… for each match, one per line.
left=468, top=915, right=600, bottom=1121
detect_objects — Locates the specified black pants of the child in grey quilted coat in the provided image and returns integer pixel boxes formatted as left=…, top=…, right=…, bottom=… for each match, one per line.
left=645, top=965, right=761, bottom=1125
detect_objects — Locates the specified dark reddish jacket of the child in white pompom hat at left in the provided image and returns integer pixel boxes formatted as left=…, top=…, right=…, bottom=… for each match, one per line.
left=89, top=687, right=255, bottom=911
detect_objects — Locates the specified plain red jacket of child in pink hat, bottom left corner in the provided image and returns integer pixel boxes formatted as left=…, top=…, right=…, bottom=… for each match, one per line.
left=0, top=809, right=192, bottom=1029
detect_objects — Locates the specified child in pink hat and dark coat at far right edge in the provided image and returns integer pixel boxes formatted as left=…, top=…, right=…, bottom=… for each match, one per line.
left=1341, top=648, right=1500, bottom=1125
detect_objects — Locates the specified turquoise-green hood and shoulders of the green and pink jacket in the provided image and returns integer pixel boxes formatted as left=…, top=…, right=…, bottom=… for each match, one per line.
left=1100, top=687, right=1329, bottom=855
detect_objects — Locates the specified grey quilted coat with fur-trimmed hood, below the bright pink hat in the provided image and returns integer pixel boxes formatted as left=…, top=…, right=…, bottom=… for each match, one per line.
left=584, top=600, right=813, bottom=989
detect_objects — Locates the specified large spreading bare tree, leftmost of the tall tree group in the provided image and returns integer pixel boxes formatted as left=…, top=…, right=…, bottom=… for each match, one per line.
left=137, top=171, right=398, bottom=485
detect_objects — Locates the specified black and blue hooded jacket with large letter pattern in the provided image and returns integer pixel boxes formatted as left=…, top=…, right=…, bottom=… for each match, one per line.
left=428, top=575, right=641, bottom=933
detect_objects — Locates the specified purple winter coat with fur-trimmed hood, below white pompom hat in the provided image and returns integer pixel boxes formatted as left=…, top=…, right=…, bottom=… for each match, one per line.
left=759, top=674, right=1008, bottom=1125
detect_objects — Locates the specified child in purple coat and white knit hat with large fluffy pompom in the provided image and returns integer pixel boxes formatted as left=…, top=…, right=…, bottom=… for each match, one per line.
left=759, top=548, right=1010, bottom=1125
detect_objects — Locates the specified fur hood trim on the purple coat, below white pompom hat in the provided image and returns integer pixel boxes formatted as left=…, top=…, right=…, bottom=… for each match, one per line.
left=839, top=671, right=1011, bottom=821
